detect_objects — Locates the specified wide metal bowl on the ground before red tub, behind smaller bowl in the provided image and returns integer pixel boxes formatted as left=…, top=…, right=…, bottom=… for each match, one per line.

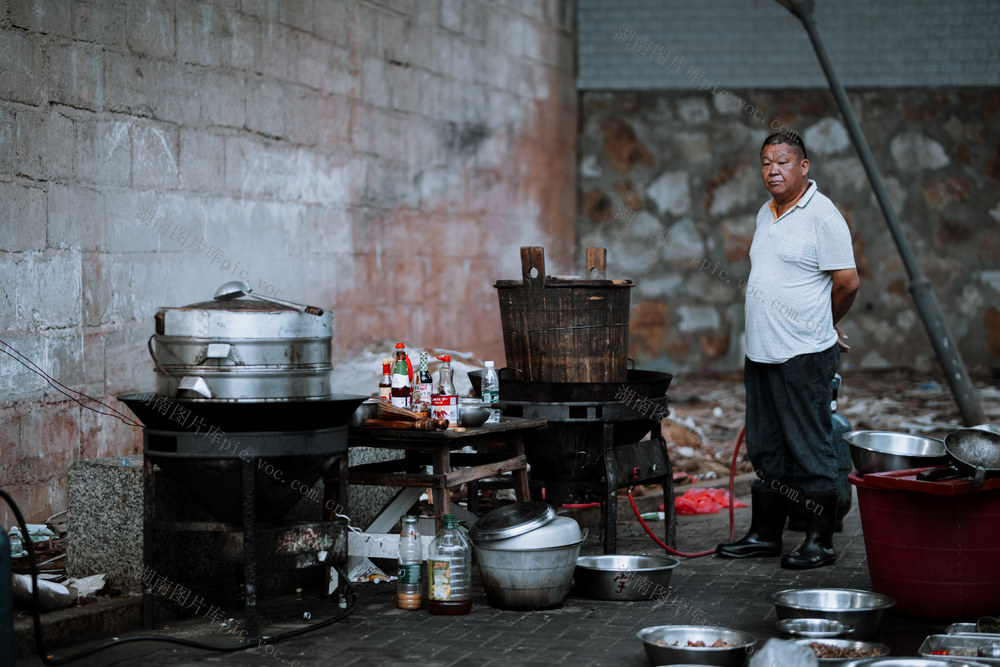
left=768, top=588, right=896, bottom=640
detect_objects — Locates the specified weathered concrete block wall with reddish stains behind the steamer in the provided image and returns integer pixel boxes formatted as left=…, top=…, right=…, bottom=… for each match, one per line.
left=0, top=0, right=576, bottom=523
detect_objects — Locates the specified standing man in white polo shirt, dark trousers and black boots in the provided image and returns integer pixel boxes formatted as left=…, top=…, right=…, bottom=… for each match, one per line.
left=716, top=133, right=858, bottom=569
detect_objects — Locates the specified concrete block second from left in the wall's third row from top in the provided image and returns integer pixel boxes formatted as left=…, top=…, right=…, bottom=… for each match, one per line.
left=15, top=108, right=76, bottom=181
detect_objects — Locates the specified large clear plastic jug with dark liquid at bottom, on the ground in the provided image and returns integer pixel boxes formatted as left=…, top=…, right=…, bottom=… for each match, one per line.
left=427, top=514, right=472, bottom=615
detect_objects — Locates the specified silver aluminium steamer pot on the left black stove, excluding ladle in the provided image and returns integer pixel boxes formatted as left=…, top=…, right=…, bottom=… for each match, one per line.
left=149, top=299, right=333, bottom=402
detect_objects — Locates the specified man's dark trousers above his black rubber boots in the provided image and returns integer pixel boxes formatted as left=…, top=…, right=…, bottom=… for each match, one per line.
left=743, top=345, right=840, bottom=500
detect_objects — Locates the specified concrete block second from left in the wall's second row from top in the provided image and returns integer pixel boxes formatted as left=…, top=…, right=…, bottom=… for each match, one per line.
left=45, top=39, right=104, bottom=110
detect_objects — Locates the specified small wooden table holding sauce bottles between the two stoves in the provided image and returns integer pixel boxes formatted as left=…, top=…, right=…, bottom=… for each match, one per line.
left=325, top=417, right=546, bottom=544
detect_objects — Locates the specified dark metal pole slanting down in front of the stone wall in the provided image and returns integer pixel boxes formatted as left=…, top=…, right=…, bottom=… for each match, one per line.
left=777, top=0, right=983, bottom=426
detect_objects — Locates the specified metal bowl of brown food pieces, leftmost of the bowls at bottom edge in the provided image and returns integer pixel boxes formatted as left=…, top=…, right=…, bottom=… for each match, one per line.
left=635, top=625, right=757, bottom=667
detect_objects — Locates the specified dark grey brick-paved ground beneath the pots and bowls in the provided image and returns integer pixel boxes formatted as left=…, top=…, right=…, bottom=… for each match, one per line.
left=20, top=494, right=943, bottom=667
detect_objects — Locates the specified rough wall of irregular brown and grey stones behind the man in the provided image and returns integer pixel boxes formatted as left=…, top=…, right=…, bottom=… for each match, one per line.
left=578, top=89, right=1000, bottom=372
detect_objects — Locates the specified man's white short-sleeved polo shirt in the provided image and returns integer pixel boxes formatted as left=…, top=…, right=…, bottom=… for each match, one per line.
left=745, top=180, right=855, bottom=364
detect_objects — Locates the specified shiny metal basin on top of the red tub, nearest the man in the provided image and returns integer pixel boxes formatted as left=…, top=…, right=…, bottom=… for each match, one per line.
left=841, top=431, right=948, bottom=475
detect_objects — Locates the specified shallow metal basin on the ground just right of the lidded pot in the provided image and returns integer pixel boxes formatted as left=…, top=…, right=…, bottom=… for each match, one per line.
left=573, top=554, right=680, bottom=601
